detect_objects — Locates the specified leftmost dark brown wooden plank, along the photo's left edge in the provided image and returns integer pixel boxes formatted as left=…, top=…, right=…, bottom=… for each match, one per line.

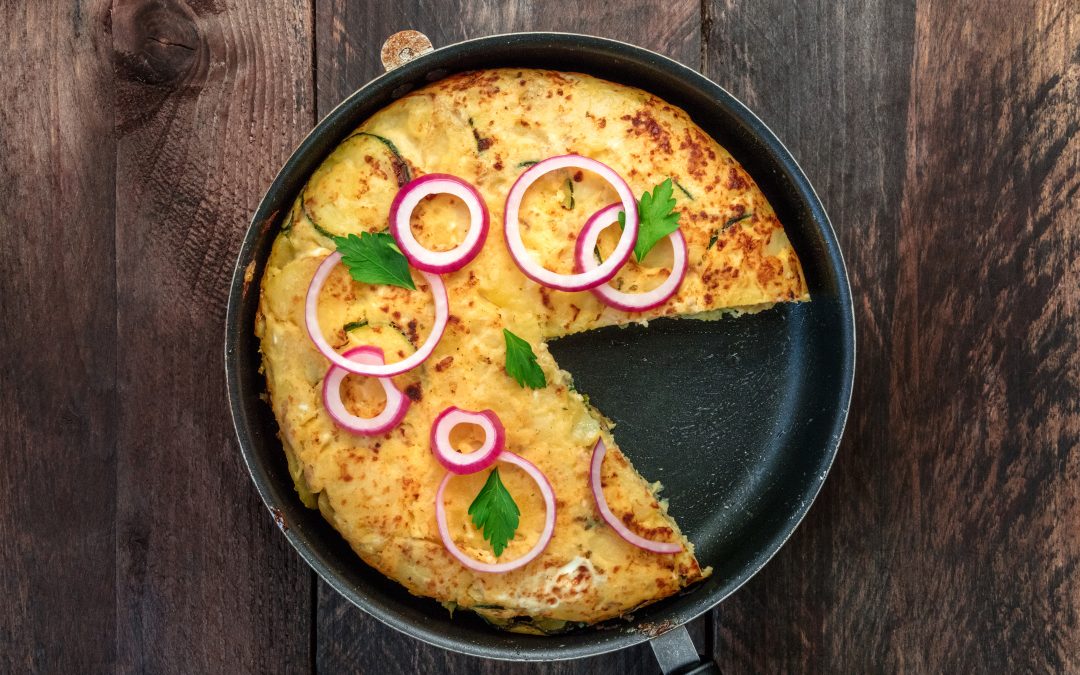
left=0, top=0, right=117, bottom=673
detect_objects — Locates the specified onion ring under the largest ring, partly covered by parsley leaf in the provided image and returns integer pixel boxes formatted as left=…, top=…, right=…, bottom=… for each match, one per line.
left=573, top=204, right=689, bottom=312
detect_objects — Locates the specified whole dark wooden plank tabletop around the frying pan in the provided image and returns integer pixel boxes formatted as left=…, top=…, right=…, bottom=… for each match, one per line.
left=0, top=0, right=1080, bottom=675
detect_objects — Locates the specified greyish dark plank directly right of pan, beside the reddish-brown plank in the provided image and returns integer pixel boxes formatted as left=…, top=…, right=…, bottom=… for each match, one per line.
left=704, top=0, right=915, bottom=673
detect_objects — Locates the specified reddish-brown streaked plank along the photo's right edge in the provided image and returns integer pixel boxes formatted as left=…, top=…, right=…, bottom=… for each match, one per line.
left=880, top=0, right=1080, bottom=673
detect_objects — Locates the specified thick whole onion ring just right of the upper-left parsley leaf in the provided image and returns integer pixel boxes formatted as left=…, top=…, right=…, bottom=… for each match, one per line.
left=390, top=174, right=488, bottom=274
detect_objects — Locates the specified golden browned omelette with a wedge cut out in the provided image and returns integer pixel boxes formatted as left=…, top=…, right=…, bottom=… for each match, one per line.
left=256, top=69, right=809, bottom=632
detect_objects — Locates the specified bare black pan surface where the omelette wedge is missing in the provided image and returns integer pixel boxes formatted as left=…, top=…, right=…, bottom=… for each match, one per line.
left=550, top=293, right=836, bottom=569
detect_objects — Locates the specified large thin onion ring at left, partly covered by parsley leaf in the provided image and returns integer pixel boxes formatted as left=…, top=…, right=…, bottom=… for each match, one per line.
left=303, top=252, right=450, bottom=377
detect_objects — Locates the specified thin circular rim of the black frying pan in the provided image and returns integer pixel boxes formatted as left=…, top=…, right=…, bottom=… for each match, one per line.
left=225, top=31, right=856, bottom=661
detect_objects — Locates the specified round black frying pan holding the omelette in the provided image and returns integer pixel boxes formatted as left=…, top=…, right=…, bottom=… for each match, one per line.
left=225, top=31, right=855, bottom=673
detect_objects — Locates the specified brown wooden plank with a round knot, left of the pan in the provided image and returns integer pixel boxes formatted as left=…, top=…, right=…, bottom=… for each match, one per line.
left=112, top=0, right=314, bottom=673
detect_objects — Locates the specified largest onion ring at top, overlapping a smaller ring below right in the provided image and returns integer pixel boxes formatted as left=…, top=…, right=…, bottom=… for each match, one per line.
left=503, top=154, right=637, bottom=291
